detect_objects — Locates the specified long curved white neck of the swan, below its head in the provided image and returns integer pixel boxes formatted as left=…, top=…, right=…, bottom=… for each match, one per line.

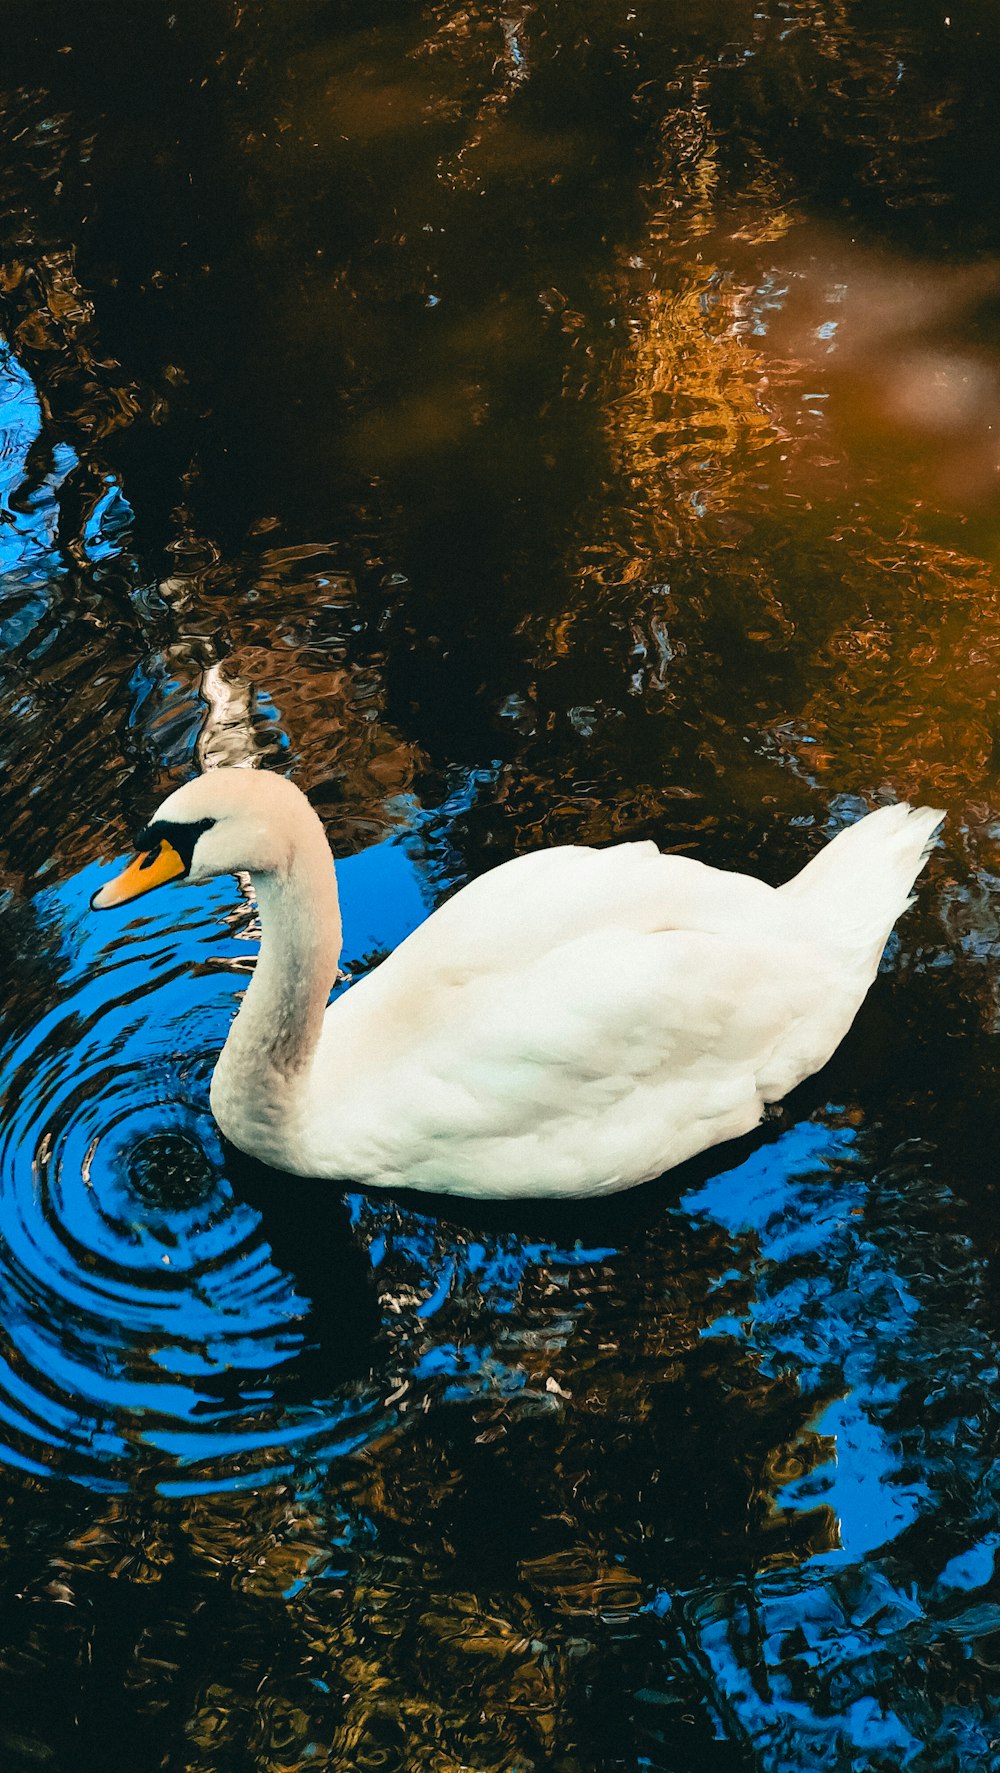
left=211, top=821, right=340, bottom=1161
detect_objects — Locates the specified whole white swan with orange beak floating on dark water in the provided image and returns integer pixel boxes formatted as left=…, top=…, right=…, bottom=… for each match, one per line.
left=94, top=769, right=943, bottom=1195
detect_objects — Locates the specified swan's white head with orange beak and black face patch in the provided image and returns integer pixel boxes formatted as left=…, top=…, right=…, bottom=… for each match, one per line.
left=90, top=769, right=326, bottom=911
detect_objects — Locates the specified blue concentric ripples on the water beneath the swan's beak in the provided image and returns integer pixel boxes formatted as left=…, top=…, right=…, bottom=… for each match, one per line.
left=0, top=851, right=434, bottom=1491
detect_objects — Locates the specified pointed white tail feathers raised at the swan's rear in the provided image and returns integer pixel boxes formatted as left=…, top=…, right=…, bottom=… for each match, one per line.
left=780, top=803, right=945, bottom=972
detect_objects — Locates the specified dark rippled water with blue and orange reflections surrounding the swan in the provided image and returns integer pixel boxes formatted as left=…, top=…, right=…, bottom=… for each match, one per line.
left=0, top=0, right=1000, bottom=1773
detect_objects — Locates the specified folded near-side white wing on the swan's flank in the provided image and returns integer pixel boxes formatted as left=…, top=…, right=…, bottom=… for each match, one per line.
left=418, top=931, right=847, bottom=1112
